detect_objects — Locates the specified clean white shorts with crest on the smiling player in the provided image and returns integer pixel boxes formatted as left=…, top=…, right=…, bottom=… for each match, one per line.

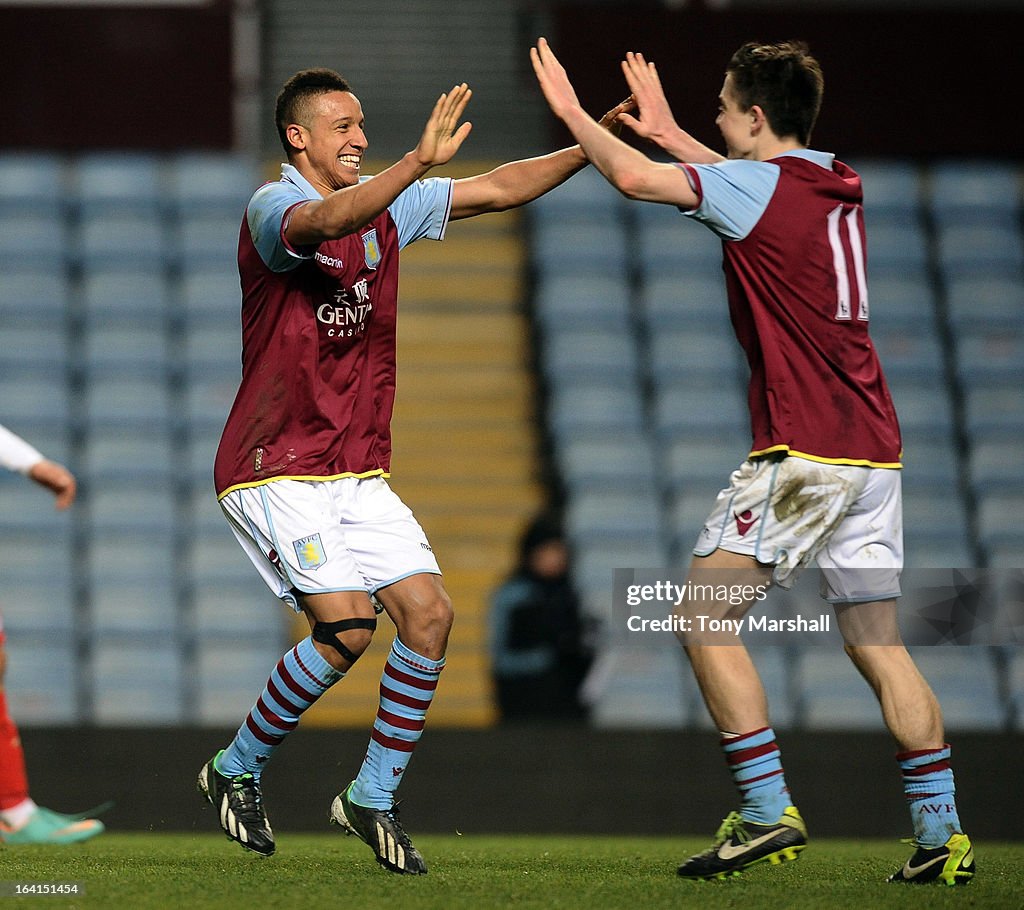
left=220, top=477, right=441, bottom=612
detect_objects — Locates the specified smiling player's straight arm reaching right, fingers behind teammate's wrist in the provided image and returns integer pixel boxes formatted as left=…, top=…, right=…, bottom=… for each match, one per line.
left=451, top=99, right=632, bottom=219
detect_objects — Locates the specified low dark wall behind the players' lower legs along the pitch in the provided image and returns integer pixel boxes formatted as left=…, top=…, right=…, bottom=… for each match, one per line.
left=23, top=726, right=1024, bottom=840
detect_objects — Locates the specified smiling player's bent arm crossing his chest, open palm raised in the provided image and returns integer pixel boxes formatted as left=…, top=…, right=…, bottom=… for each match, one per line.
left=286, top=83, right=473, bottom=247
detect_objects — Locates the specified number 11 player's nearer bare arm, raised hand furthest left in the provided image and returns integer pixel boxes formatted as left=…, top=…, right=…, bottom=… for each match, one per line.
left=529, top=38, right=699, bottom=209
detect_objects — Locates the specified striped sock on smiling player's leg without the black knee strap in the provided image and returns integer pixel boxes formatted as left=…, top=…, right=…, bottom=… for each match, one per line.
left=351, top=638, right=444, bottom=810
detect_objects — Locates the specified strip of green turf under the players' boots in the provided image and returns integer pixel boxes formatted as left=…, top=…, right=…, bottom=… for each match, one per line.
left=0, top=833, right=1024, bottom=910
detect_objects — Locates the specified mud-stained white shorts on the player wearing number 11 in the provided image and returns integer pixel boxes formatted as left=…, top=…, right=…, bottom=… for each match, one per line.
left=693, top=456, right=903, bottom=603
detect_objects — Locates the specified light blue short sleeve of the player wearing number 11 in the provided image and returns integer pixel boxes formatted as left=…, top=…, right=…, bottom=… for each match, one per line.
left=683, top=159, right=781, bottom=241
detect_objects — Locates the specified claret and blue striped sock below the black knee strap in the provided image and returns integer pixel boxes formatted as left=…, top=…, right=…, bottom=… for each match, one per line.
left=216, top=638, right=345, bottom=778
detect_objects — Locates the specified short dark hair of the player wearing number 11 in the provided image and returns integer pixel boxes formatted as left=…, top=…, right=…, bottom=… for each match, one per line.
left=725, top=41, right=824, bottom=145
